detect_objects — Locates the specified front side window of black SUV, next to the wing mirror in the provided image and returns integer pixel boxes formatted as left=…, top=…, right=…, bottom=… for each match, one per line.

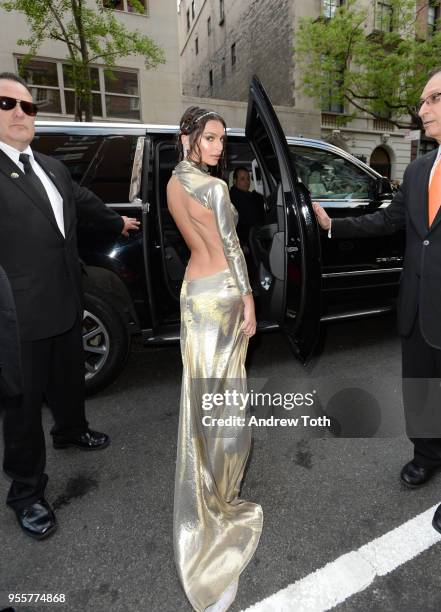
left=290, top=145, right=375, bottom=203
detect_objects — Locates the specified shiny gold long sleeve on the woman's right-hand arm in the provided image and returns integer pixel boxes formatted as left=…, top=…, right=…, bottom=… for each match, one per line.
left=210, top=181, right=251, bottom=295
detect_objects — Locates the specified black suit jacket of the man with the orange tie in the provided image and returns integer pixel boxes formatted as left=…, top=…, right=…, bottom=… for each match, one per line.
left=332, top=150, right=441, bottom=349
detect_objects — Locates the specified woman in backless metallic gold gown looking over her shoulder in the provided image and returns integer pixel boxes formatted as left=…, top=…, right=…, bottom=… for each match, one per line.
left=167, top=107, right=263, bottom=612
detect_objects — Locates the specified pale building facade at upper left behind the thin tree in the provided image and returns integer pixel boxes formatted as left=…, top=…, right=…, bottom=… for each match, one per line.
left=0, top=0, right=182, bottom=124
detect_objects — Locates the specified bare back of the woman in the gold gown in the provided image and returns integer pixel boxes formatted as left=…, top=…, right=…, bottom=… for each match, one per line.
left=167, top=176, right=228, bottom=280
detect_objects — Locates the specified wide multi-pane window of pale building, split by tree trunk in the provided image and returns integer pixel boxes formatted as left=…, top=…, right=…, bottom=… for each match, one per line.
left=17, top=58, right=141, bottom=120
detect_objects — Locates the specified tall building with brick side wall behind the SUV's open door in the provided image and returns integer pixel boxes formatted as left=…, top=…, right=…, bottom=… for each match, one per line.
left=178, top=0, right=439, bottom=180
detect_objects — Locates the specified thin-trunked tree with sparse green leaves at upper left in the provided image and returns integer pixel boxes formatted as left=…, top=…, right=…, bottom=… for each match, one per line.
left=0, top=0, right=165, bottom=121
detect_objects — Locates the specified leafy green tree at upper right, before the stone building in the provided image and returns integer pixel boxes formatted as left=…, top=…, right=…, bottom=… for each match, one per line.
left=295, top=0, right=441, bottom=127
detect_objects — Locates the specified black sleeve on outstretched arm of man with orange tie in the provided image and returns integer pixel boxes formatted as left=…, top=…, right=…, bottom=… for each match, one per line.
left=331, top=171, right=408, bottom=238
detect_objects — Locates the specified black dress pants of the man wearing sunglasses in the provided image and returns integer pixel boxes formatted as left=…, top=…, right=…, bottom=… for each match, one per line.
left=3, top=319, right=88, bottom=510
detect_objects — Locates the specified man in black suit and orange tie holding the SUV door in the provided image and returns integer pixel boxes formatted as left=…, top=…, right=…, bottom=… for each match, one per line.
left=314, top=69, right=441, bottom=533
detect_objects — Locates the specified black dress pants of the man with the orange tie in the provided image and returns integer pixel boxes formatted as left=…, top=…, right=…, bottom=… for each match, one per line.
left=401, top=314, right=441, bottom=469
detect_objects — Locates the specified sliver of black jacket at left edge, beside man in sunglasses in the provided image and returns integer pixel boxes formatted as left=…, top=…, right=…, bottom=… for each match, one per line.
left=0, top=266, right=23, bottom=398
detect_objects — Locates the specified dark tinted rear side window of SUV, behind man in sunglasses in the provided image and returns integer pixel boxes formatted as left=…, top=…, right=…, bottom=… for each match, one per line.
left=32, top=132, right=137, bottom=204
